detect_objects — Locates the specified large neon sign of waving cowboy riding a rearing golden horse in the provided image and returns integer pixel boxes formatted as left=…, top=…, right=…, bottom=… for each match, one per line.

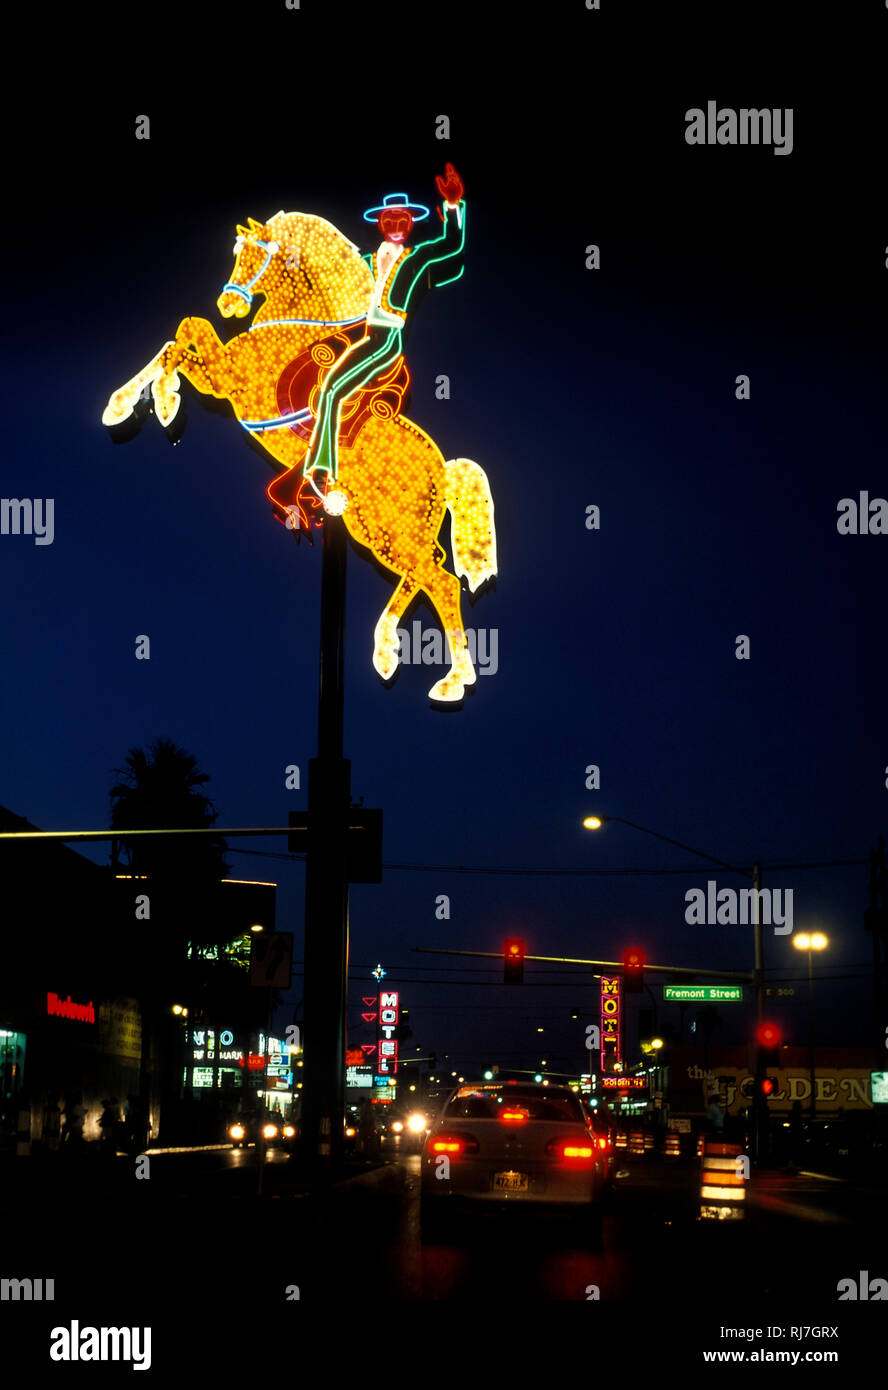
left=101, top=175, right=498, bottom=705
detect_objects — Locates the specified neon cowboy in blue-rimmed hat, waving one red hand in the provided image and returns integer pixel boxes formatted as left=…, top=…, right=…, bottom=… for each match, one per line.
left=303, top=164, right=466, bottom=513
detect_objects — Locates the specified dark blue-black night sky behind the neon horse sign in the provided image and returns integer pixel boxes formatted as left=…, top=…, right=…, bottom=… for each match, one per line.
left=0, top=0, right=888, bottom=1070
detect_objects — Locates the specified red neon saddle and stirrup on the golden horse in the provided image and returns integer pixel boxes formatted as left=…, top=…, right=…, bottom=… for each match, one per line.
left=265, top=324, right=410, bottom=539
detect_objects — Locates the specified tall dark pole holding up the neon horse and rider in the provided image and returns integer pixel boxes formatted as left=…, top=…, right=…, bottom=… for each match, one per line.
left=300, top=514, right=352, bottom=1182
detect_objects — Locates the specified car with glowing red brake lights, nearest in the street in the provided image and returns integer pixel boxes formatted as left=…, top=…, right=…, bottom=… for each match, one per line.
left=422, top=1081, right=609, bottom=1245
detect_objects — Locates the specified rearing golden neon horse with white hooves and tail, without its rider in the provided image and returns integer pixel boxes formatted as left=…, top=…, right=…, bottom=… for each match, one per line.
left=101, top=211, right=496, bottom=705
